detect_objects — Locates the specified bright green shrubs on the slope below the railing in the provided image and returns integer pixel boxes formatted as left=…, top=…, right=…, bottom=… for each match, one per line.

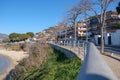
left=19, top=50, right=82, bottom=80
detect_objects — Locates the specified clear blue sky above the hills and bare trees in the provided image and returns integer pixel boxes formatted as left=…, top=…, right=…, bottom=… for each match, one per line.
left=0, top=0, right=118, bottom=34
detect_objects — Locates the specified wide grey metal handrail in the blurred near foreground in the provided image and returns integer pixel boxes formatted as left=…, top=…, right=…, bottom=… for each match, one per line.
left=78, top=43, right=117, bottom=80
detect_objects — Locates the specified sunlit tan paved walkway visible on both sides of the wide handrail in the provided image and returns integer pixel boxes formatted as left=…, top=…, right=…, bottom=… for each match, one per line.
left=59, top=46, right=120, bottom=80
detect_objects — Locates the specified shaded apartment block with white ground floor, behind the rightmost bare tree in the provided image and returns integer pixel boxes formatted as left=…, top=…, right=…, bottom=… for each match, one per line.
left=88, top=11, right=120, bottom=45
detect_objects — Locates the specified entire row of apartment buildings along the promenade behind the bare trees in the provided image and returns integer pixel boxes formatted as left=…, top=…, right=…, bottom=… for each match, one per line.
left=57, top=11, right=120, bottom=46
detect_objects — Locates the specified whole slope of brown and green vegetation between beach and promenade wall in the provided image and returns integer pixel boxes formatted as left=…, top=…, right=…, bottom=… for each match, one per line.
left=7, top=45, right=82, bottom=80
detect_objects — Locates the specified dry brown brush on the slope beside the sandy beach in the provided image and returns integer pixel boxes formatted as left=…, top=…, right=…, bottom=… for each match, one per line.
left=7, top=43, right=53, bottom=80
